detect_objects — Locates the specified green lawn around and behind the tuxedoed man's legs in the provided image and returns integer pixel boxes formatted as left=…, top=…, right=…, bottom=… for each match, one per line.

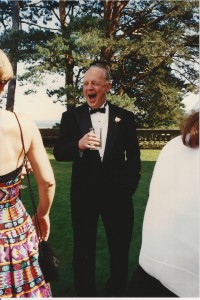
left=22, top=149, right=160, bottom=297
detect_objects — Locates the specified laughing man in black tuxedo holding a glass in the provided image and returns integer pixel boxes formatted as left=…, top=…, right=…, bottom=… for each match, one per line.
left=54, top=65, right=140, bottom=297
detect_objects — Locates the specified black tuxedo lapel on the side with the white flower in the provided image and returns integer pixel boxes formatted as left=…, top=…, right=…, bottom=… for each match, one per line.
left=103, top=103, right=119, bottom=160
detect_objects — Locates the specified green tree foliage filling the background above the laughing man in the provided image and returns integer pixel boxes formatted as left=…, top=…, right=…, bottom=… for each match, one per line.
left=0, top=0, right=198, bottom=128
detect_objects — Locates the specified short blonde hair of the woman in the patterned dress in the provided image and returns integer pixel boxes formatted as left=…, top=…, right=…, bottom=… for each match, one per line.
left=0, top=49, right=14, bottom=80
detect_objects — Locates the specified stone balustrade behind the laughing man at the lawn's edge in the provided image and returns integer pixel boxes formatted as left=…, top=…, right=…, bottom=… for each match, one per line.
left=40, top=129, right=180, bottom=149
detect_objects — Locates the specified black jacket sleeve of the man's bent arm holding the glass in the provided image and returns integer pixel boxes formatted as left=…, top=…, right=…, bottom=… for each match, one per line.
left=53, top=111, right=80, bottom=161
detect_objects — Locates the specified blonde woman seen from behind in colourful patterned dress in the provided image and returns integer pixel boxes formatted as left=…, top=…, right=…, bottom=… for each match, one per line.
left=0, top=50, right=55, bottom=298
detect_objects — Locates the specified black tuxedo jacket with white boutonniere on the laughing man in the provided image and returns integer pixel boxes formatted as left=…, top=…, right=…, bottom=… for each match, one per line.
left=54, top=103, right=141, bottom=202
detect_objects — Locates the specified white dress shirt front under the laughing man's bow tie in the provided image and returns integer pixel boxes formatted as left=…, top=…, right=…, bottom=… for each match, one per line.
left=90, top=104, right=109, bottom=160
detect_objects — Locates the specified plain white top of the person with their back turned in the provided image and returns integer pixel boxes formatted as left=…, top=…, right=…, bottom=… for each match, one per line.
left=139, top=136, right=200, bottom=297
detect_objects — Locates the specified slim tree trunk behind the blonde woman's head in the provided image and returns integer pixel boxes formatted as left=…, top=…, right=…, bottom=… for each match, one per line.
left=6, top=1, right=20, bottom=111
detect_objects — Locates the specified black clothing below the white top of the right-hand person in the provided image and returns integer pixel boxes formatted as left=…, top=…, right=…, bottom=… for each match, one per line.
left=127, top=265, right=178, bottom=298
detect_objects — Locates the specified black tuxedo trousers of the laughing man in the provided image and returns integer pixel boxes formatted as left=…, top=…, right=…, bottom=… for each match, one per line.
left=72, top=199, right=134, bottom=297
